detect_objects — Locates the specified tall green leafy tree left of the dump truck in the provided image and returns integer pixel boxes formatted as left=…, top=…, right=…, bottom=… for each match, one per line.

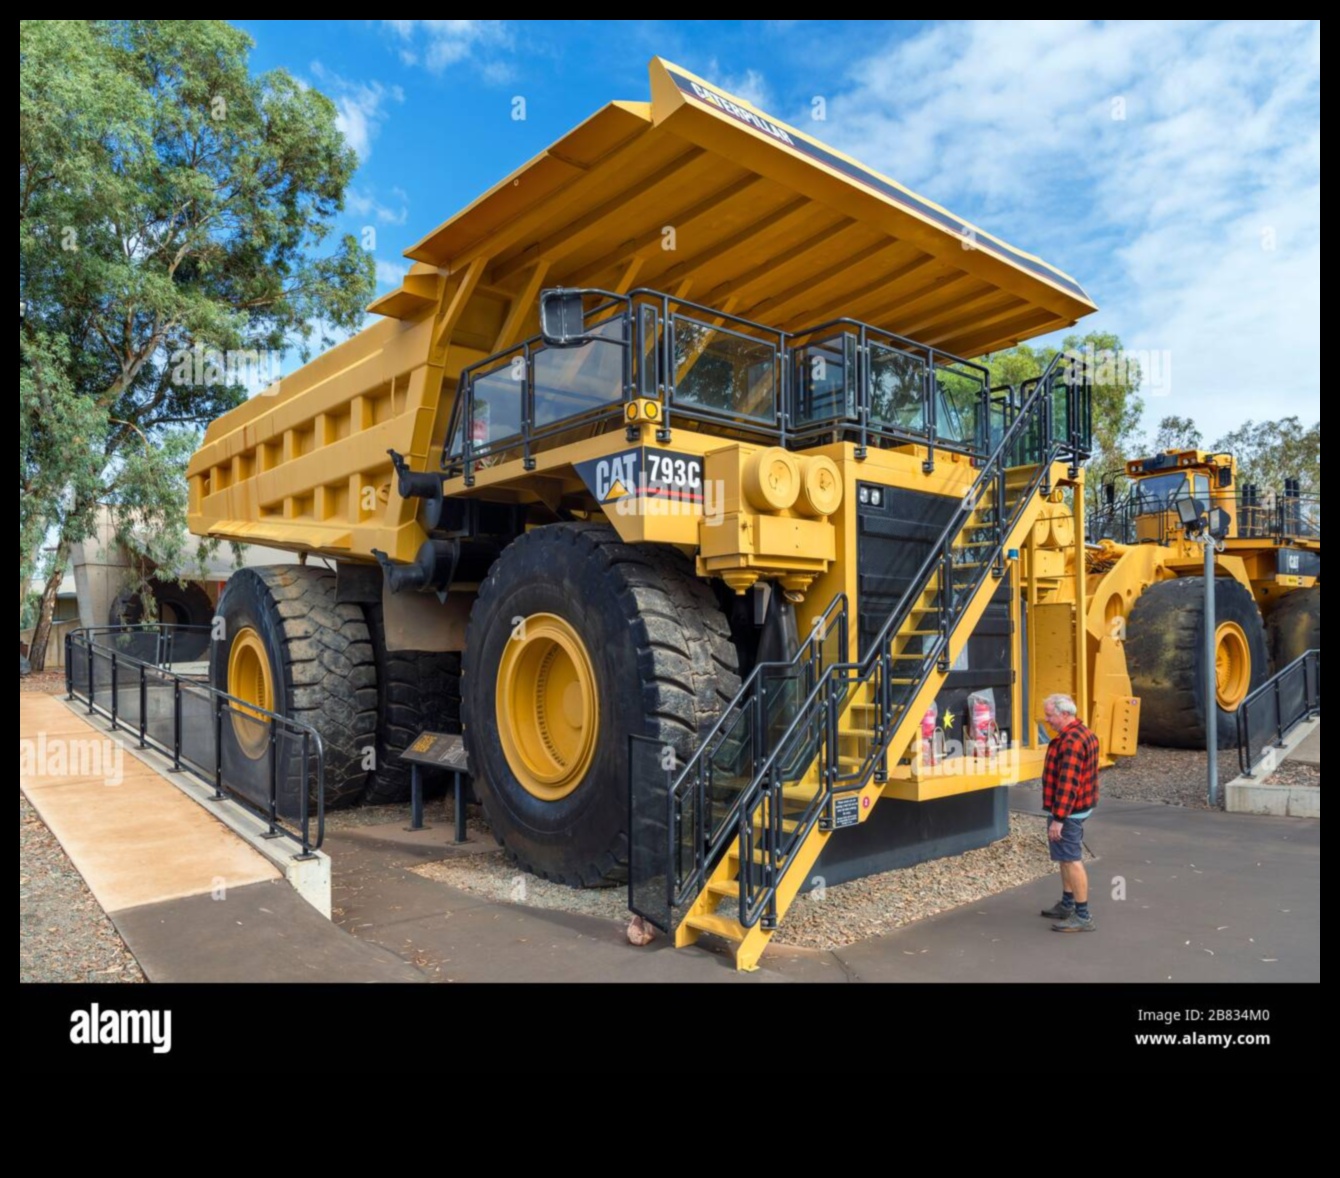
left=19, top=20, right=374, bottom=645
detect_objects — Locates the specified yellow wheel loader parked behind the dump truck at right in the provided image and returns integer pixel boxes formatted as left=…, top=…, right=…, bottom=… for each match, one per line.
left=1087, top=450, right=1321, bottom=748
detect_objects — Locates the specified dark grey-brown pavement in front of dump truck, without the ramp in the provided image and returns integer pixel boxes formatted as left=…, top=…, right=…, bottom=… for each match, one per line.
left=327, top=789, right=1321, bottom=984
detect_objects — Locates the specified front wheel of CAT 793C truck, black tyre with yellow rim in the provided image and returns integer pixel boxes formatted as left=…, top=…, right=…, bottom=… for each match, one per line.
left=462, top=524, right=740, bottom=887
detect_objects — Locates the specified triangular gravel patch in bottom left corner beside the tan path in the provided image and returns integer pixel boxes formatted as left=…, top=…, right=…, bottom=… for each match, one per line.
left=19, top=793, right=145, bottom=982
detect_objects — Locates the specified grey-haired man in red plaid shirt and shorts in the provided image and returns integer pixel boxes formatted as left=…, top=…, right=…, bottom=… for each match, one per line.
left=1043, top=696, right=1099, bottom=933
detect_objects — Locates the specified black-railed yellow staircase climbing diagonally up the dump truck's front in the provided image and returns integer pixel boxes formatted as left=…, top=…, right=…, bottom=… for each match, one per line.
left=628, top=345, right=1089, bottom=927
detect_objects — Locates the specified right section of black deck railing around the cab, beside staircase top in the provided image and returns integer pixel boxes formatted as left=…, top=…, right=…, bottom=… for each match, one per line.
left=788, top=319, right=992, bottom=464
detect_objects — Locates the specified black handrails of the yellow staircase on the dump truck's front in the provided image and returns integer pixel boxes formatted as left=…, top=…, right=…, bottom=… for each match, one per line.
left=666, top=355, right=1088, bottom=927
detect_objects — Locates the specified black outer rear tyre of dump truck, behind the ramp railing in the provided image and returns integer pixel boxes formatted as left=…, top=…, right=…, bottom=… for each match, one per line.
left=209, top=564, right=377, bottom=809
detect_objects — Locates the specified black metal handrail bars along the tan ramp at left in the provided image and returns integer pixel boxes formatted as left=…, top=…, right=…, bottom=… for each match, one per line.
left=66, top=623, right=326, bottom=858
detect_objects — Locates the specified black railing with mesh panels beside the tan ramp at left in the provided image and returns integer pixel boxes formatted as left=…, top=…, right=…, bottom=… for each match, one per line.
left=66, top=625, right=326, bottom=856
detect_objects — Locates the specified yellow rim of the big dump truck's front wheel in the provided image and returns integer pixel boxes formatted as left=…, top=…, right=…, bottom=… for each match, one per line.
left=497, top=614, right=600, bottom=801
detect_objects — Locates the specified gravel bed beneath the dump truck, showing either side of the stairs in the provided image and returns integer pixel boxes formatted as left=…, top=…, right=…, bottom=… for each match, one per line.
left=410, top=815, right=1072, bottom=949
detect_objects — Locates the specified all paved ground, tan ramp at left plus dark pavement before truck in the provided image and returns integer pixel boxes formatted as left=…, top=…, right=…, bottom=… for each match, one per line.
left=20, top=696, right=1321, bottom=985
